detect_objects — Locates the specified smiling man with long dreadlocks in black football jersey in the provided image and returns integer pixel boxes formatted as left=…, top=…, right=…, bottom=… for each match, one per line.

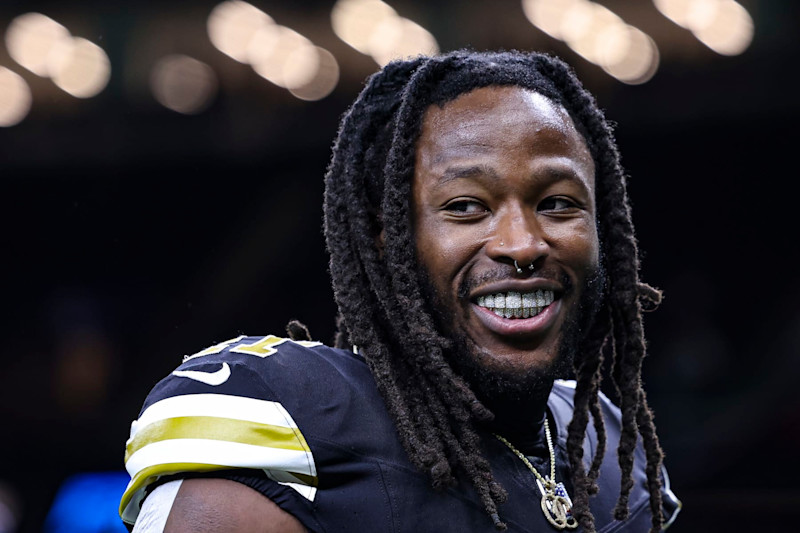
left=120, top=52, right=679, bottom=532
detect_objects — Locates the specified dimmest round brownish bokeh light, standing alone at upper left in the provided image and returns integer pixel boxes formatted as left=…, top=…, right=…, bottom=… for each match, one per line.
left=150, top=54, right=218, bottom=115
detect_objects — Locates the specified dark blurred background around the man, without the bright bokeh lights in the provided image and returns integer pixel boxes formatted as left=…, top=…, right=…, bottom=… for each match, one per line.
left=0, top=0, right=800, bottom=532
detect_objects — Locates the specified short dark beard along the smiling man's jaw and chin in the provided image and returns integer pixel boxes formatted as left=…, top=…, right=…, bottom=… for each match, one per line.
left=421, top=264, right=606, bottom=412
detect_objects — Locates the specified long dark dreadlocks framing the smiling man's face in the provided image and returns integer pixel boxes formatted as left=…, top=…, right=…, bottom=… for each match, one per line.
left=318, top=51, right=663, bottom=532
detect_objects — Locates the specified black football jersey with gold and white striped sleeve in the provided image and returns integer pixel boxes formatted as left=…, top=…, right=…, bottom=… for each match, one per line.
left=120, top=335, right=680, bottom=533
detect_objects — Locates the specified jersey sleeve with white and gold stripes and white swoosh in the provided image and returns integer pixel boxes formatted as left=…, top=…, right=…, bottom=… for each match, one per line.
left=120, top=336, right=319, bottom=524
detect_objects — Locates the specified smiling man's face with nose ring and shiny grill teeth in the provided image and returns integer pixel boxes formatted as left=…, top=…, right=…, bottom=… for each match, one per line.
left=413, top=87, right=599, bottom=375
